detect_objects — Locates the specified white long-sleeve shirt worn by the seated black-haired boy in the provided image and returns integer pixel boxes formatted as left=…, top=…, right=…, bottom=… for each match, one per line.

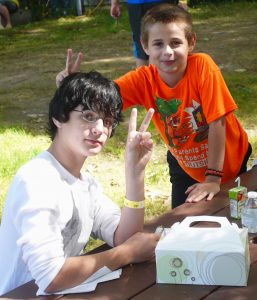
left=0, top=151, right=120, bottom=295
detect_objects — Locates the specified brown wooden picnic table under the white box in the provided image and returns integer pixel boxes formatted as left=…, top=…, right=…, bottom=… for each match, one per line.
left=0, top=166, right=257, bottom=300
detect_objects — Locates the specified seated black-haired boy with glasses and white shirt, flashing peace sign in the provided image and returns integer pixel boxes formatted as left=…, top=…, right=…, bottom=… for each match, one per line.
left=0, top=72, right=159, bottom=295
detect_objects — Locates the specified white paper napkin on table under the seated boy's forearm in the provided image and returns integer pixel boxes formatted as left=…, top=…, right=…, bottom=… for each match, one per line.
left=37, top=267, right=122, bottom=296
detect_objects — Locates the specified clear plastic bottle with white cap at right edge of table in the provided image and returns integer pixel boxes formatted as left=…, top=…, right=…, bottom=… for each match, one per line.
left=241, top=192, right=257, bottom=233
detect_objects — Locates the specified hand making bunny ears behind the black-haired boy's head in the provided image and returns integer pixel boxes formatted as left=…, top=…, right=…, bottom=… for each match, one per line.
left=56, top=49, right=83, bottom=87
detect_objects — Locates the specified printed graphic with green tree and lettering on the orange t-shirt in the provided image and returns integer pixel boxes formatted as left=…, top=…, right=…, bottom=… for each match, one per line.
left=156, top=97, right=209, bottom=168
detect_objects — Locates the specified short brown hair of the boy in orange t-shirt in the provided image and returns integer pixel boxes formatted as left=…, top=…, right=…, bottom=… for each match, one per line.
left=141, top=3, right=194, bottom=45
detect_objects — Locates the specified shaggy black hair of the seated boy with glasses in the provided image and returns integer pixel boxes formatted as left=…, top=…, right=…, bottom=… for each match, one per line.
left=48, top=71, right=122, bottom=140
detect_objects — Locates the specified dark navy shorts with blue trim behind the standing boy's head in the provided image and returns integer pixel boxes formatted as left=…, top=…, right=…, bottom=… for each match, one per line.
left=127, top=0, right=179, bottom=60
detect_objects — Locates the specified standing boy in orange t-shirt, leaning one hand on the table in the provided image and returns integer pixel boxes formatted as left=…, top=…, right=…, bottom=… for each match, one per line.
left=57, top=4, right=251, bottom=208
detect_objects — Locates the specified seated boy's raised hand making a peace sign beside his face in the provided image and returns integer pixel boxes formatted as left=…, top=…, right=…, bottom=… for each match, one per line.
left=125, top=108, right=154, bottom=176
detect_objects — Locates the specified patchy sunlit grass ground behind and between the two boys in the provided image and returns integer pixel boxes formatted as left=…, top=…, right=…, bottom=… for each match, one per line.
left=0, top=1, right=257, bottom=232
